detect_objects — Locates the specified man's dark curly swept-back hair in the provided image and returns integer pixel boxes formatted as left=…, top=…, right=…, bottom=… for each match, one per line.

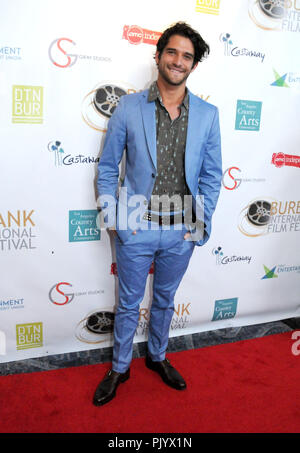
left=156, top=22, right=210, bottom=67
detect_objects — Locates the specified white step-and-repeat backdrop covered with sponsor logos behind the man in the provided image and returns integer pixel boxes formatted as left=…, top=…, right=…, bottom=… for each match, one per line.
left=0, top=0, right=300, bottom=362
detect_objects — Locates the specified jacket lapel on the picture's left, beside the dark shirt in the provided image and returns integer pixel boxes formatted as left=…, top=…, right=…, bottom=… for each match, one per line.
left=141, top=90, right=156, bottom=168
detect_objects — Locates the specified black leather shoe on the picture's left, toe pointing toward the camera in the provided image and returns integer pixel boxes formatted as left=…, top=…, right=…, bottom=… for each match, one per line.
left=93, top=368, right=130, bottom=406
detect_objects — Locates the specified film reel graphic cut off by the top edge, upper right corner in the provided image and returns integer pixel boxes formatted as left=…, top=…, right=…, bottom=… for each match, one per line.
left=248, top=0, right=287, bottom=31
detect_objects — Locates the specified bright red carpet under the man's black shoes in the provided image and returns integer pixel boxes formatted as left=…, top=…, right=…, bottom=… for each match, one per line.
left=0, top=332, right=300, bottom=433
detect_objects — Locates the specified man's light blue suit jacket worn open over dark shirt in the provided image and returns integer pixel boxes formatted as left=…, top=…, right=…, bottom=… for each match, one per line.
left=97, top=90, right=222, bottom=245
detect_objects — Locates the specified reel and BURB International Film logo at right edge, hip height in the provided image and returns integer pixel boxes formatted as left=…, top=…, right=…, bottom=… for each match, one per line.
left=238, top=198, right=300, bottom=238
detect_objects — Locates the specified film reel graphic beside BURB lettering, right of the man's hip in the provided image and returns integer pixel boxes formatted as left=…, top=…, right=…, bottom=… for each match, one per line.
left=238, top=199, right=272, bottom=237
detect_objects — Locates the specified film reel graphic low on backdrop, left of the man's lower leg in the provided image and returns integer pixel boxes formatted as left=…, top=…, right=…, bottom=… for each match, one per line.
left=75, top=310, right=115, bottom=344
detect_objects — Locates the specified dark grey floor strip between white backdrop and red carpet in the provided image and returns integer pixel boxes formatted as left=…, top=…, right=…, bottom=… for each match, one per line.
left=0, top=318, right=300, bottom=376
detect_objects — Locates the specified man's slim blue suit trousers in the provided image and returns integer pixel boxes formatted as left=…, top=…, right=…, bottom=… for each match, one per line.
left=112, top=222, right=195, bottom=373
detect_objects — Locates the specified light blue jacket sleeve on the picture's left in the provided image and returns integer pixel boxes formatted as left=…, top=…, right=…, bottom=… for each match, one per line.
left=97, top=96, right=127, bottom=227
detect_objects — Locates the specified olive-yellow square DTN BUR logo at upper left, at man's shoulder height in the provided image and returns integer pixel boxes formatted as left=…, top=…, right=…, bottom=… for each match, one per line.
left=12, top=85, right=43, bottom=124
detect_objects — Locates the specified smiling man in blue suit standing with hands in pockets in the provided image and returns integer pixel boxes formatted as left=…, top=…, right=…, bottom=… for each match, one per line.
left=93, top=22, right=222, bottom=406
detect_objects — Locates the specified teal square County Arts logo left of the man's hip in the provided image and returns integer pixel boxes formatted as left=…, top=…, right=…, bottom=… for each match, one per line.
left=69, top=209, right=100, bottom=242
